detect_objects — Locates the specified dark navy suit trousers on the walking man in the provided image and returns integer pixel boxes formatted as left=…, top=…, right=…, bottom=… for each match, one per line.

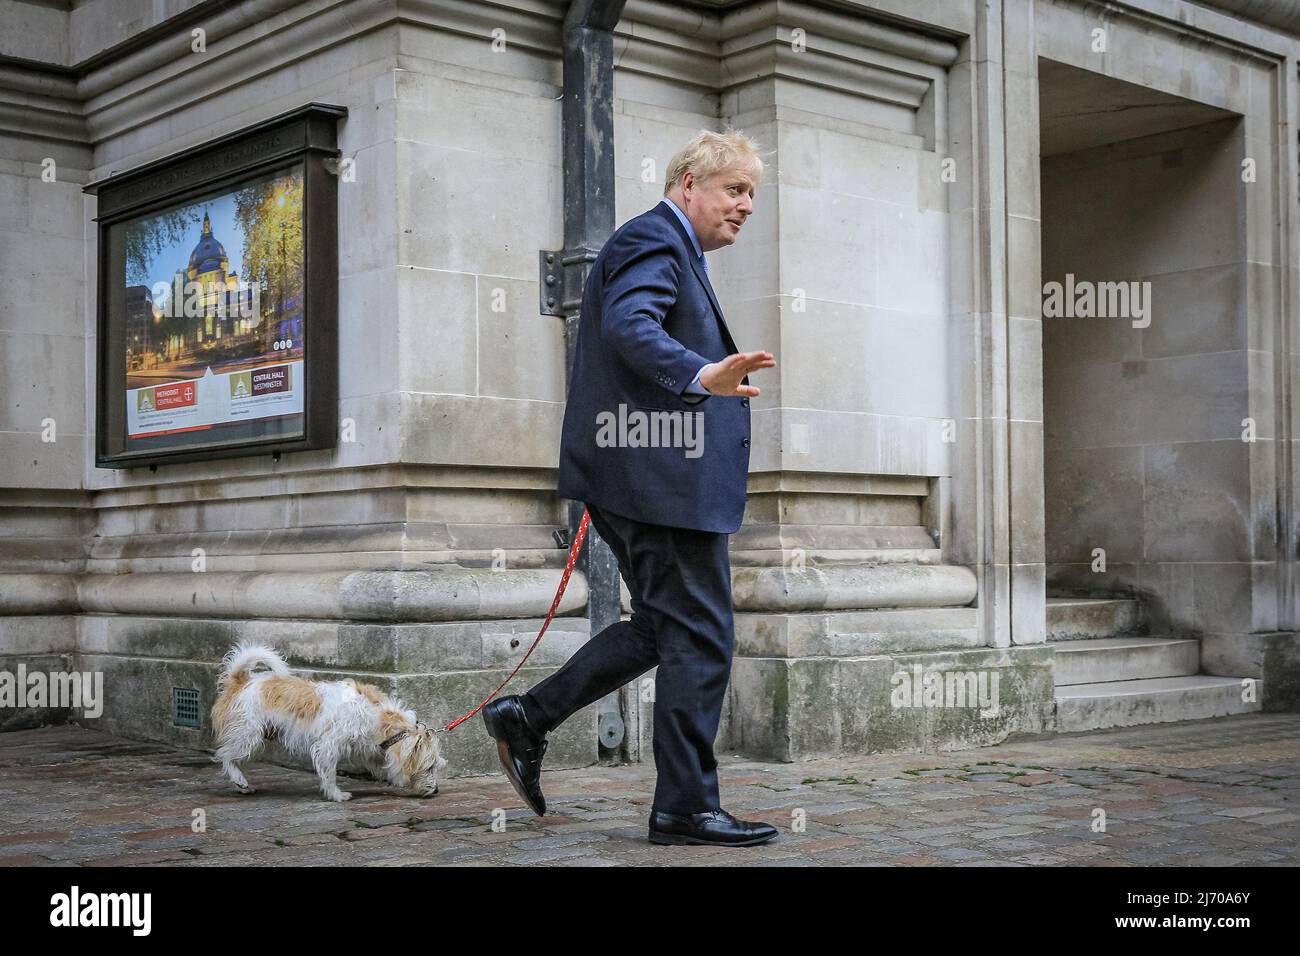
left=524, top=503, right=736, bottom=814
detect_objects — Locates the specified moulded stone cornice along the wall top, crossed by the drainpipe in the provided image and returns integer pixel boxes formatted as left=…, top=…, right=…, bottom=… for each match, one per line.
left=0, top=0, right=977, bottom=144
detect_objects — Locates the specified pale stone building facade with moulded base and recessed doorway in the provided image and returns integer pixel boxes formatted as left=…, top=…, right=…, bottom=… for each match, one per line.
left=0, top=0, right=1300, bottom=773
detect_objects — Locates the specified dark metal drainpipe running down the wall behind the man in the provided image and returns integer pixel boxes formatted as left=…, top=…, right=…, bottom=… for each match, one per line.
left=541, top=0, right=627, bottom=753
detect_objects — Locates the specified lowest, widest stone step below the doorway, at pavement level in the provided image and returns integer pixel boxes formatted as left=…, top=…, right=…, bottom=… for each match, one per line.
left=1056, top=674, right=1264, bottom=734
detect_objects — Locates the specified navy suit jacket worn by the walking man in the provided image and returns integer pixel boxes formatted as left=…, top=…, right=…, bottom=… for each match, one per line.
left=558, top=203, right=750, bottom=535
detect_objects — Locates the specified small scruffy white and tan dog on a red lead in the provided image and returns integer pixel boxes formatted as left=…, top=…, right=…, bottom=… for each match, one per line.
left=212, top=643, right=447, bottom=800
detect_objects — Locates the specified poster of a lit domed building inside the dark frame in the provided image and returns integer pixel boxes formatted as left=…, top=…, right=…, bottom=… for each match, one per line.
left=122, top=166, right=304, bottom=438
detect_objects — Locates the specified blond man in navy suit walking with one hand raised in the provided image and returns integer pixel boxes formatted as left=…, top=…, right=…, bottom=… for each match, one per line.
left=484, top=130, right=776, bottom=845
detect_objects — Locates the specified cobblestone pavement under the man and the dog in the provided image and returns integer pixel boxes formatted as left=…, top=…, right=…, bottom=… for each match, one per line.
left=0, top=714, right=1300, bottom=866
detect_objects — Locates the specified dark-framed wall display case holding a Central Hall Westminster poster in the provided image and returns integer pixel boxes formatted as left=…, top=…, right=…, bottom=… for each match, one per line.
left=86, top=103, right=346, bottom=468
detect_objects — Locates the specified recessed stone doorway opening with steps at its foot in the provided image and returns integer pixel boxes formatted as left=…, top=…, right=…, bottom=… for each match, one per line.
left=1039, top=59, right=1252, bottom=730
